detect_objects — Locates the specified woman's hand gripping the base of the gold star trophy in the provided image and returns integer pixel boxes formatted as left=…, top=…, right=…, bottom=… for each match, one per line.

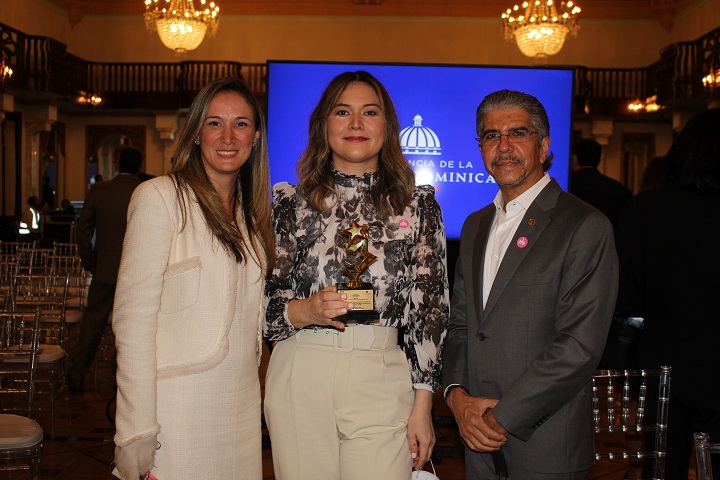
left=288, top=287, right=353, bottom=331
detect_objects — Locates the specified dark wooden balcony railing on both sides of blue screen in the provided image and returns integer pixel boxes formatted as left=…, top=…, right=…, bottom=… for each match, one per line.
left=0, top=23, right=720, bottom=114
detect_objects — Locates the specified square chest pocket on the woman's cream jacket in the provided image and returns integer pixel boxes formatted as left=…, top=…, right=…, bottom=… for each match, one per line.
left=160, top=257, right=202, bottom=313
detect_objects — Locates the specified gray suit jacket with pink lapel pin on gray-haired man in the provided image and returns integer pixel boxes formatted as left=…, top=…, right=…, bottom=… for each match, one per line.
left=443, top=180, right=618, bottom=473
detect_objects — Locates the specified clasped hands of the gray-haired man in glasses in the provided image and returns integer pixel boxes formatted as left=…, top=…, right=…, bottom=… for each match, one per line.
left=447, top=388, right=507, bottom=452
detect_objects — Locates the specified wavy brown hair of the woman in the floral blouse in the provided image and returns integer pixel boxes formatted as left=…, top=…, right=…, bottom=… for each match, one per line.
left=297, top=70, right=415, bottom=215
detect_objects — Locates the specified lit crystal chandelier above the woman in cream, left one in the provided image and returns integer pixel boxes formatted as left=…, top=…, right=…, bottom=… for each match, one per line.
left=145, top=0, right=220, bottom=55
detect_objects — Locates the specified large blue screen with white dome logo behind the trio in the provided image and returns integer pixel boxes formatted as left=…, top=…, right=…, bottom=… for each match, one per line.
left=268, top=61, right=573, bottom=239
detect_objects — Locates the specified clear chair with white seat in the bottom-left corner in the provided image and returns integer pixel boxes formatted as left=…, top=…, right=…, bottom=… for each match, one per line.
left=0, top=309, right=43, bottom=479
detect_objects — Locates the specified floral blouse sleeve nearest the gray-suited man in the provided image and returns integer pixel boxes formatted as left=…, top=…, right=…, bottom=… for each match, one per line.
left=405, top=187, right=450, bottom=391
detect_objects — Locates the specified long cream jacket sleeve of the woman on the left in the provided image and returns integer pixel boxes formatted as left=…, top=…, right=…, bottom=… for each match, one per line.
left=112, top=178, right=177, bottom=447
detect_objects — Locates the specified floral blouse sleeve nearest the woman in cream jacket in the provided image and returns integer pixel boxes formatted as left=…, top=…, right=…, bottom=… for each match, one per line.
left=263, top=183, right=298, bottom=341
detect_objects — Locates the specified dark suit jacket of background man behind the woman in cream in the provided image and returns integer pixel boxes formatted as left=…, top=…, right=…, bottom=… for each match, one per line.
left=77, top=173, right=140, bottom=284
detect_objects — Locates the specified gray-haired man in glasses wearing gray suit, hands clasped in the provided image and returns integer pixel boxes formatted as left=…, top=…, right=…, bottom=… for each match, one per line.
left=443, top=90, right=618, bottom=480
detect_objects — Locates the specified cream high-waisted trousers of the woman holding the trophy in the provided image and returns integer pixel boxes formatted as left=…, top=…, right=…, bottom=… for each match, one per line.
left=265, top=325, right=414, bottom=480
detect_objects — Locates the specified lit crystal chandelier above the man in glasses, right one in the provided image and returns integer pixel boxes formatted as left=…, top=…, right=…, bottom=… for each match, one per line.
left=502, top=0, right=580, bottom=59
